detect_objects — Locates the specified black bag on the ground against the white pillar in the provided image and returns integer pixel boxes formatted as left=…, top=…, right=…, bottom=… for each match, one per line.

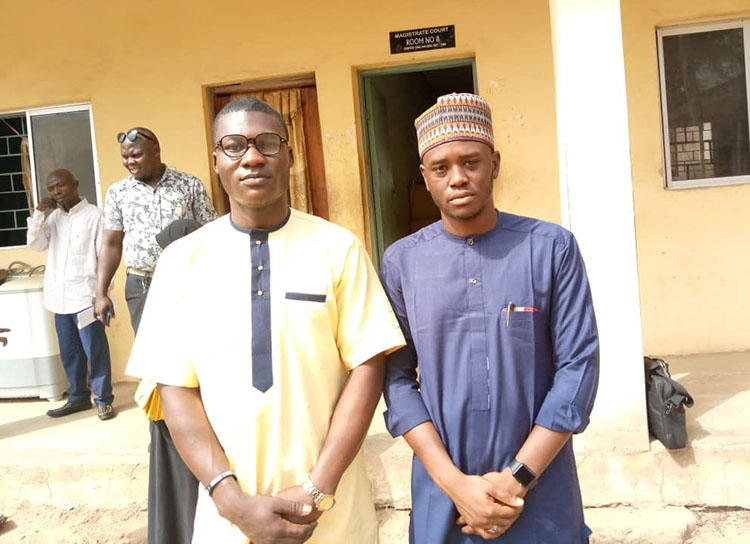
left=643, top=357, right=693, bottom=449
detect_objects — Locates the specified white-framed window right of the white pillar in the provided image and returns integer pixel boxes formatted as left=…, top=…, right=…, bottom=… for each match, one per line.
left=657, top=21, right=750, bottom=189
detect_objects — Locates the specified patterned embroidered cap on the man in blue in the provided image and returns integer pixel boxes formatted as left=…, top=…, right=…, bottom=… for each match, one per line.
left=414, top=93, right=495, bottom=159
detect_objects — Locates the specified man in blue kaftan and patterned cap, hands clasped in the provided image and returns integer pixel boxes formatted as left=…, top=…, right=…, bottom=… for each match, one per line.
left=381, top=94, right=599, bottom=544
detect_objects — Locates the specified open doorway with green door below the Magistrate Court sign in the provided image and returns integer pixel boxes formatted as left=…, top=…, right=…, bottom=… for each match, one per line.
left=359, top=59, right=476, bottom=266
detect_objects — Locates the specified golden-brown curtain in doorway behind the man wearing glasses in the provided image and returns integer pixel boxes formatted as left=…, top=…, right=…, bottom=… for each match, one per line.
left=230, top=88, right=313, bottom=213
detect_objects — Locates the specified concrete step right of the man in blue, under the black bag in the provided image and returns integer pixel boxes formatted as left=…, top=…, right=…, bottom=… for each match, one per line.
left=576, top=352, right=750, bottom=510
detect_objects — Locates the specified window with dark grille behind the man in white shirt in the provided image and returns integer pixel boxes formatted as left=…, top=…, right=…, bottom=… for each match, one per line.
left=0, top=104, right=101, bottom=247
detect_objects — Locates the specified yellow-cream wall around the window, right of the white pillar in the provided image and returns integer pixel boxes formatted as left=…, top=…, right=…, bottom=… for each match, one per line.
left=624, top=0, right=750, bottom=354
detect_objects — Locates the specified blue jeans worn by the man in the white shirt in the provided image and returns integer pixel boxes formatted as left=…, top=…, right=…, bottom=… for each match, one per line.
left=55, top=314, right=114, bottom=404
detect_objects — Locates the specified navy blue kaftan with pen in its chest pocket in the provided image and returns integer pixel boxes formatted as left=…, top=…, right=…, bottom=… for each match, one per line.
left=381, top=212, right=599, bottom=544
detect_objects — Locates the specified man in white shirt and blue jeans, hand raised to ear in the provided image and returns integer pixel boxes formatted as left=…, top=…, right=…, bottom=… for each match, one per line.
left=26, top=169, right=114, bottom=420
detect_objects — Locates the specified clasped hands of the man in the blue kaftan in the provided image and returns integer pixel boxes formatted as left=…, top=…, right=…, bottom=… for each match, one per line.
left=451, top=468, right=527, bottom=540
